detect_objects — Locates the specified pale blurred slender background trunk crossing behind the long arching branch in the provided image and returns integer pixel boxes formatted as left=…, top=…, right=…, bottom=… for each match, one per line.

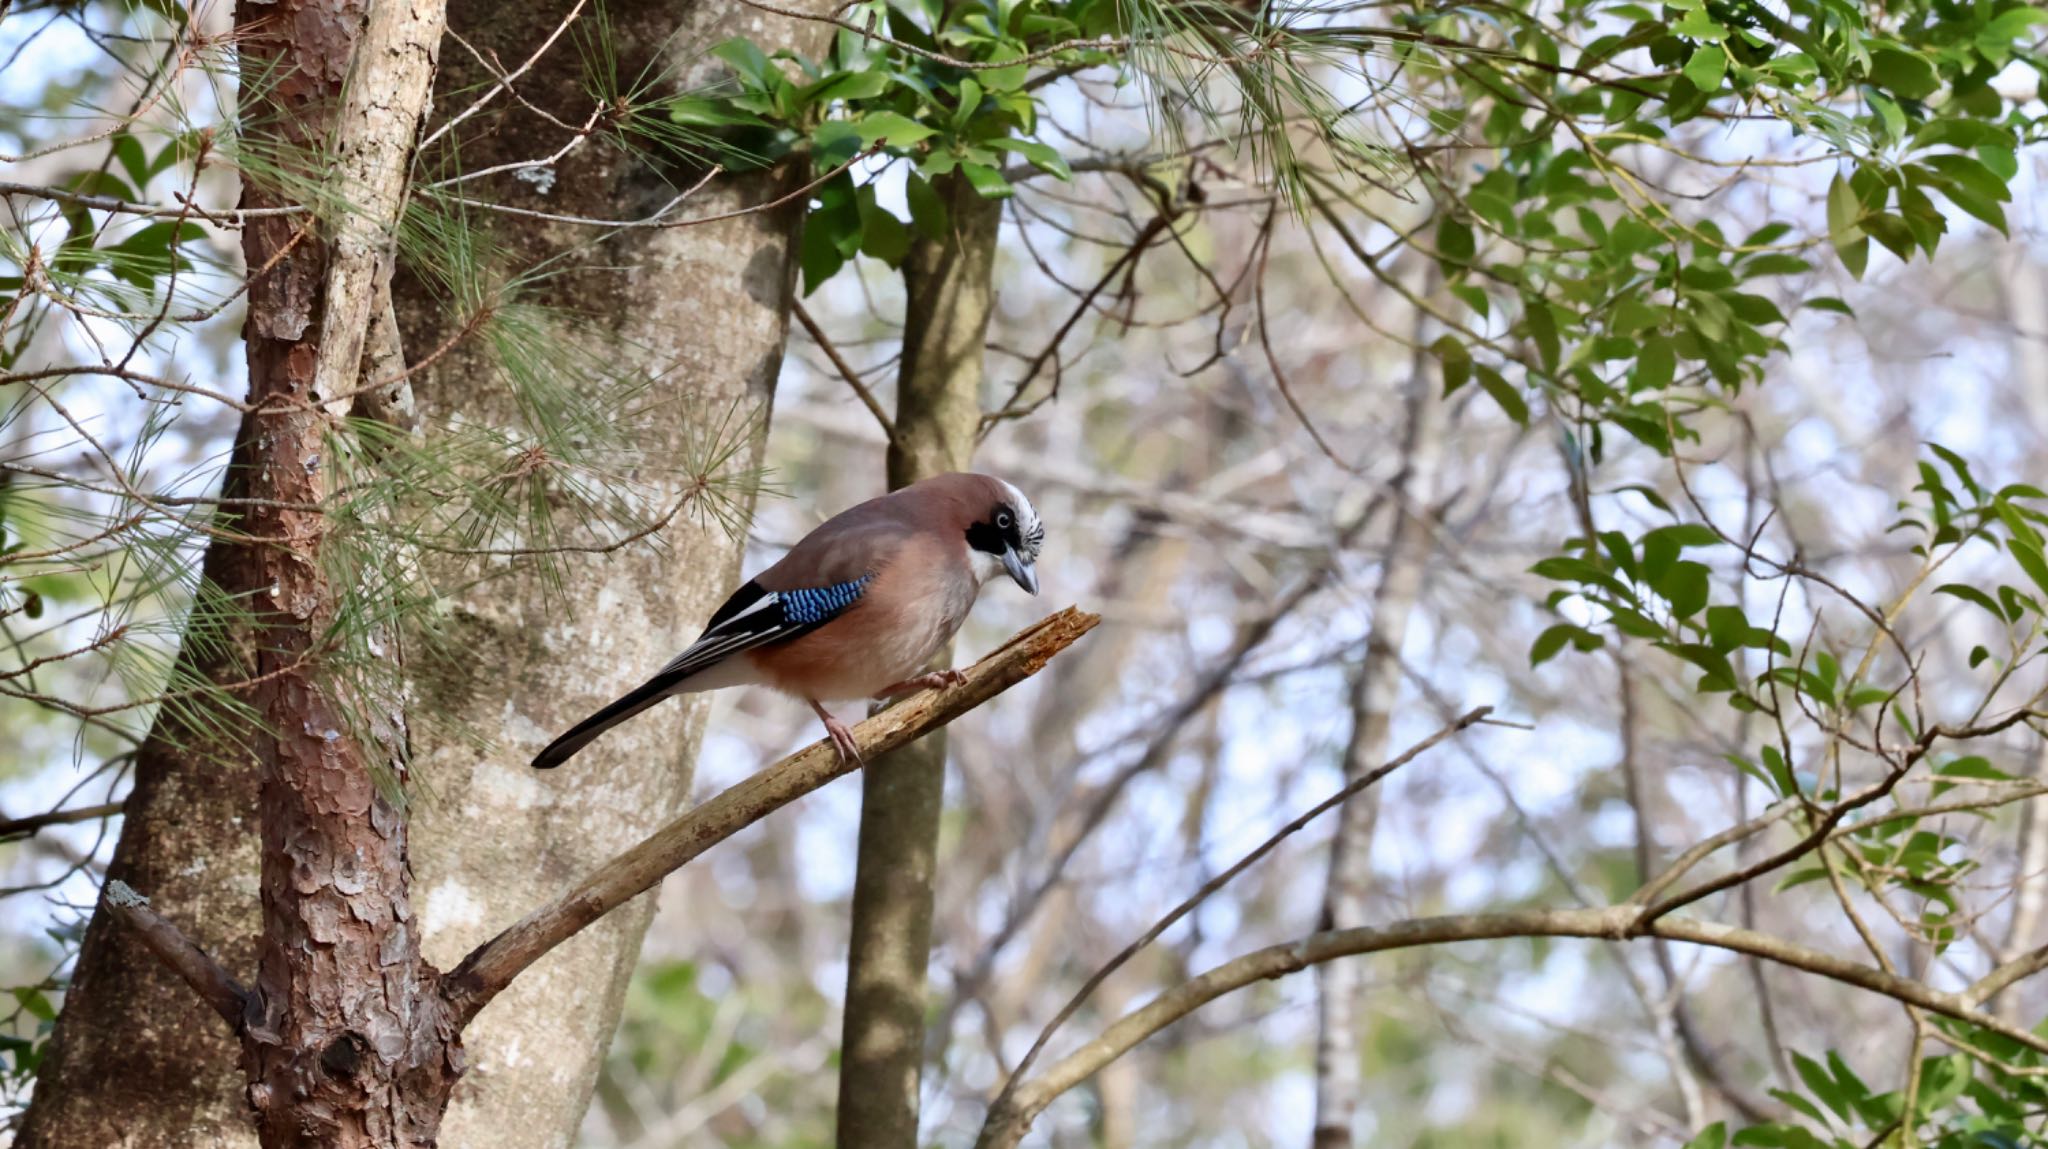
left=1313, top=356, right=1444, bottom=1149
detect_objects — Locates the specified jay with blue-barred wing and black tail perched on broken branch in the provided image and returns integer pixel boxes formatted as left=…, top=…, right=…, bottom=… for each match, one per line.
left=532, top=473, right=1044, bottom=770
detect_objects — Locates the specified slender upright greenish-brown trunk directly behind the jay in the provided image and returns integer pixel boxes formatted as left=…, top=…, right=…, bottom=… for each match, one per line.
left=838, top=176, right=1001, bottom=1149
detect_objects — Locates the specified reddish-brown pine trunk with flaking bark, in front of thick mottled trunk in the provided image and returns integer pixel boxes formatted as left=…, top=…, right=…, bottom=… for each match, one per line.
left=238, top=0, right=463, bottom=1147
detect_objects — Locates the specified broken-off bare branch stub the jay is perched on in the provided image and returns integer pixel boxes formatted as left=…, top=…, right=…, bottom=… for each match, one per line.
left=440, top=606, right=1102, bottom=1026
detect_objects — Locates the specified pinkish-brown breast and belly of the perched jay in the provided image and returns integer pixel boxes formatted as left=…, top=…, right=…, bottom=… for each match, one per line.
left=748, top=535, right=979, bottom=703
